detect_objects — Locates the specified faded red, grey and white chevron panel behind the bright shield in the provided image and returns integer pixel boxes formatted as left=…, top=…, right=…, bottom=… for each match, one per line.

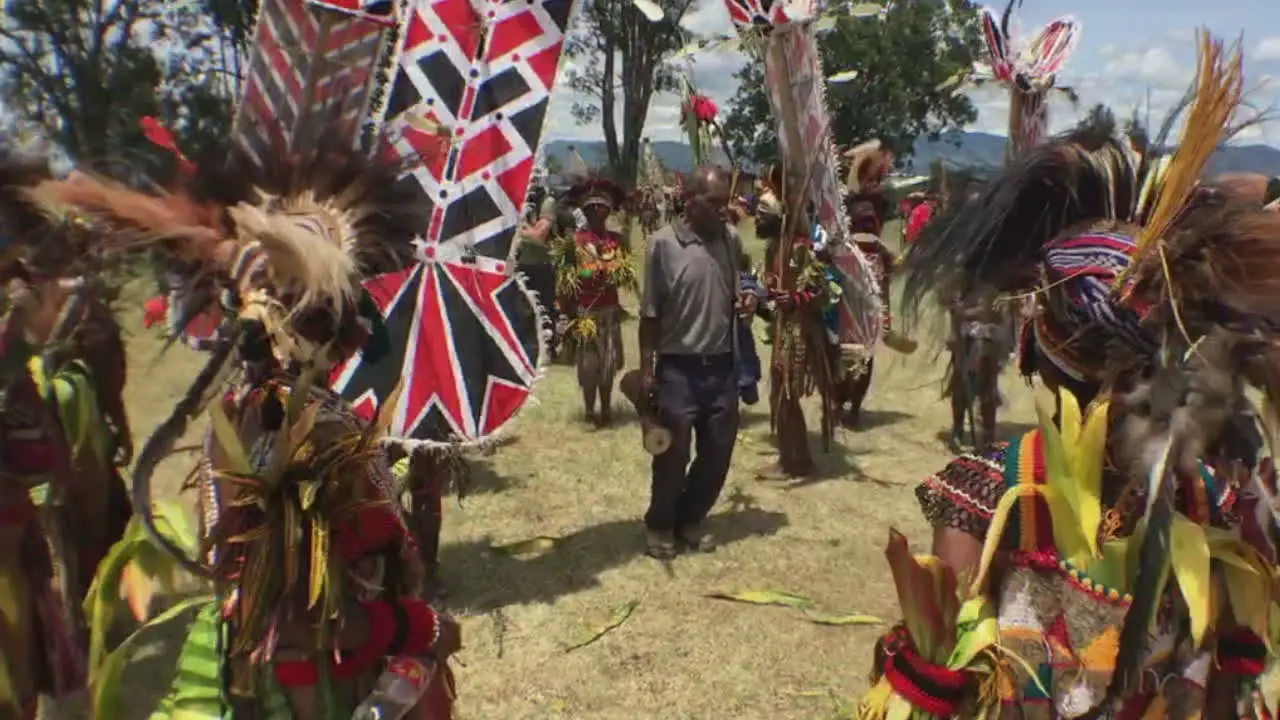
left=232, top=0, right=387, bottom=161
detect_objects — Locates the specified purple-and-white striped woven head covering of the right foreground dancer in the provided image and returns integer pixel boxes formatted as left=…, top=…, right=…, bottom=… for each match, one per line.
left=1032, top=232, right=1157, bottom=382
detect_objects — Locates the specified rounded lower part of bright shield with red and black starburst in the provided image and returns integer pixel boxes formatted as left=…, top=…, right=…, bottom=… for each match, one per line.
left=330, top=243, right=545, bottom=446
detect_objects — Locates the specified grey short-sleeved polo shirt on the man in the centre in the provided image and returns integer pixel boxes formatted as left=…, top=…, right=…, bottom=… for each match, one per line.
left=640, top=219, right=742, bottom=355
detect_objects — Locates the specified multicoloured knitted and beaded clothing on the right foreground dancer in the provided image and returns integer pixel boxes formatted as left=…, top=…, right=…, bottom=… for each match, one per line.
left=916, top=430, right=1248, bottom=720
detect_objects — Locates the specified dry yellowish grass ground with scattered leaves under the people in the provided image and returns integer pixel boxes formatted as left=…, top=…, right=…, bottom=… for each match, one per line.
left=112, top=220, right=1049, bottom=720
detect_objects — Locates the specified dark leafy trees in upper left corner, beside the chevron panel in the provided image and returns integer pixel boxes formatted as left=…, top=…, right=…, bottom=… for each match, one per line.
left=0, top=0, right=257, bottom=181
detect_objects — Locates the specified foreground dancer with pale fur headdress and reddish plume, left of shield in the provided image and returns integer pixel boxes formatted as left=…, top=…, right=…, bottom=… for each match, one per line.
left=33, top=118, right=458, bottom=717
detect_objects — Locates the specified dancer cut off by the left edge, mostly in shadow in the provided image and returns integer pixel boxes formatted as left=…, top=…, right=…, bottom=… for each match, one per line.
left=0, top=151, right=132, bottom=717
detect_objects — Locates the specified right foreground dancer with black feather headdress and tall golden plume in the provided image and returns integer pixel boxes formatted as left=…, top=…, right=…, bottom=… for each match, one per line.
left=859, top=37, right=1280, bottom=719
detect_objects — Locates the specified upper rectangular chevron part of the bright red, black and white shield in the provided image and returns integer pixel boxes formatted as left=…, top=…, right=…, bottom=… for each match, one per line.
left=373, top=0, right=572, bottom=259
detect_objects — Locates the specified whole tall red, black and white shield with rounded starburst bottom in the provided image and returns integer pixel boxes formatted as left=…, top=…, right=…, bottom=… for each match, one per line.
left=332, top=0, right=573, bottom=447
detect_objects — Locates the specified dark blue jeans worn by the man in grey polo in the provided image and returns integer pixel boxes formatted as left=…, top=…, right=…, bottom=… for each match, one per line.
left=644, top=352, right=739, bottom=532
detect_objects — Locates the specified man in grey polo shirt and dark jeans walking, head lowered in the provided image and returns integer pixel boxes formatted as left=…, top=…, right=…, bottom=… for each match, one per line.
left=640, top=168, right=742, bottom=560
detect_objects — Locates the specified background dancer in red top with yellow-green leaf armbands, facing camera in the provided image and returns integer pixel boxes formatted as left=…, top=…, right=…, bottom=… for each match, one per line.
left=557, top=178, right=636, bottom=427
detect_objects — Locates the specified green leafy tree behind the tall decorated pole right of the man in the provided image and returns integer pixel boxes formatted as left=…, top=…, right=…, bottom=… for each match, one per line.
left=724, top=0, right=983, bottom=163
